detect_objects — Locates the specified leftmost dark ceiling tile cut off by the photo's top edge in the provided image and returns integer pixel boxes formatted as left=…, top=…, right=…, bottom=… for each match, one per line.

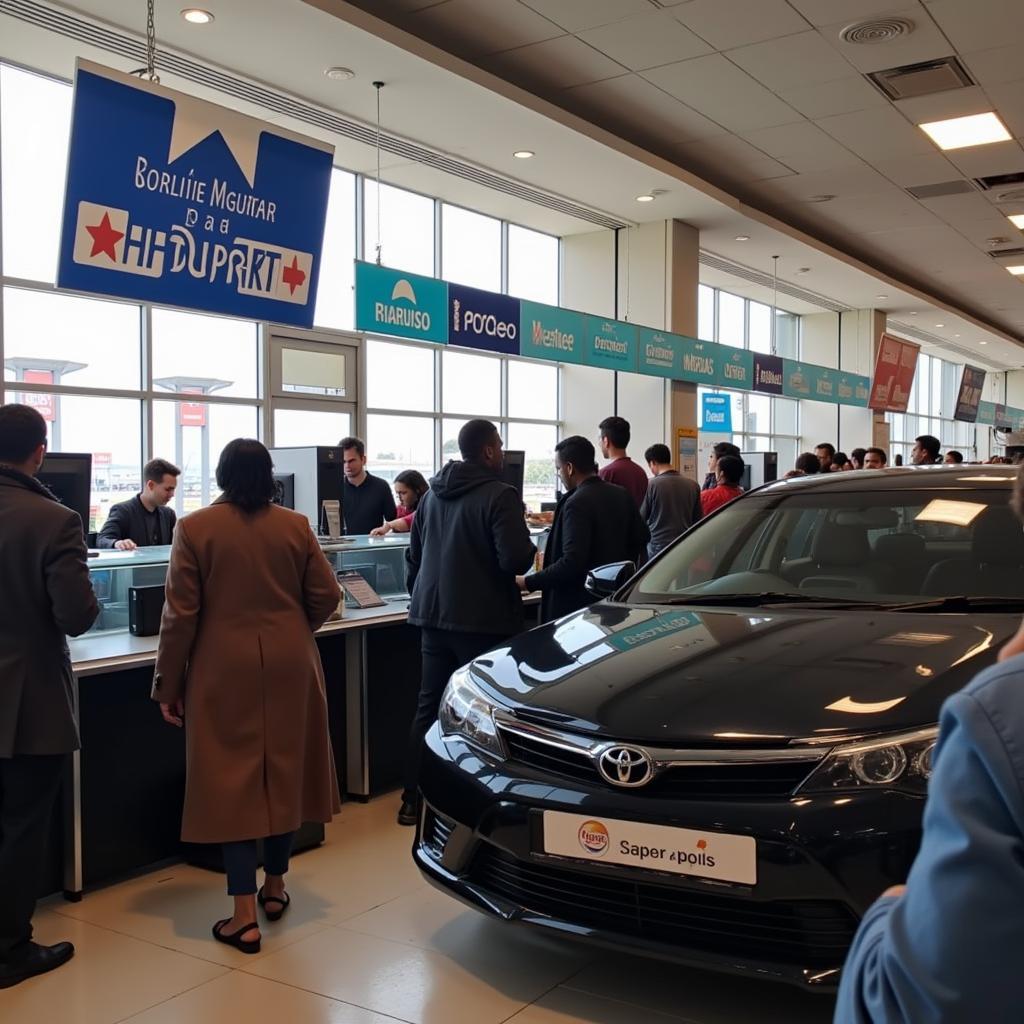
left=408, top=0, right=564, bottom=56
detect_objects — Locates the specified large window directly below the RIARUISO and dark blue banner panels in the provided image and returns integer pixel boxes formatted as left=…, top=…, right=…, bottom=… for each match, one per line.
left=367, top=339, right=560, bottom=511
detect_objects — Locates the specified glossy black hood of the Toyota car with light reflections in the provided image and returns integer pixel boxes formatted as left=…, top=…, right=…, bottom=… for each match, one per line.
left=471, top=602, right=1020, bottom=745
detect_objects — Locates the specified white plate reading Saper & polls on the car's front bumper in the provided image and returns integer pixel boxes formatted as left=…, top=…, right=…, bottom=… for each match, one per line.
left=544, top=811, right=758, bottom=886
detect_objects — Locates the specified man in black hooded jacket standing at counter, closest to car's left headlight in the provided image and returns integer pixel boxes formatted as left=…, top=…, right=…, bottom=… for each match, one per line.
left=398, top=420, right=536, bottom=825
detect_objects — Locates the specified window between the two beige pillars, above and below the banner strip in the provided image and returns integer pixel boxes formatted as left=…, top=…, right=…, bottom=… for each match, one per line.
left=697, top=285, right=800, bottom=467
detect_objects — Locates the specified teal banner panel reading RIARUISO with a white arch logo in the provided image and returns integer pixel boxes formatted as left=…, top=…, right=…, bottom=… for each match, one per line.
left=355, top=260, right=449, bottom=344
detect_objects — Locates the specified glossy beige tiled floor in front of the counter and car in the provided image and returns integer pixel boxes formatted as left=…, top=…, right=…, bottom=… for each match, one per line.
left=0, top=797, right=831, bottom=1024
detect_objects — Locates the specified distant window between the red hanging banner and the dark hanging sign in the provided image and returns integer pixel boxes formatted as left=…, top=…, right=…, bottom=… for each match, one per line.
left=886, top=352, right=978, bottom=465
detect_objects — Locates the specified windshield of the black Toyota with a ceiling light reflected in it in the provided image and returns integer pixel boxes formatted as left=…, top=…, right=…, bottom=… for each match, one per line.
left=625, top=484, right=1024, bottom=607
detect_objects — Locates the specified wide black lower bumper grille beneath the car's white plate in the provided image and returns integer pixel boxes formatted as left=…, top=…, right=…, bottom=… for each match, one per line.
left=469, top=843, right=857, bottom=968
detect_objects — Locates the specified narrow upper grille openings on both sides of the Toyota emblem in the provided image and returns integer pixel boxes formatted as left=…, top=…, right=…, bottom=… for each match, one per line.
left=502, top=729, right=820, bottom=800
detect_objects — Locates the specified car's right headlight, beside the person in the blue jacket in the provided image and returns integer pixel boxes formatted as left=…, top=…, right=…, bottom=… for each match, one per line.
left=799, top=726, right=939, bottom=795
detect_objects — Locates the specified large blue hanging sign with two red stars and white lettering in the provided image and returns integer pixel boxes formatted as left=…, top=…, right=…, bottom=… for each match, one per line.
left=57, top=60, right=334, bottom=327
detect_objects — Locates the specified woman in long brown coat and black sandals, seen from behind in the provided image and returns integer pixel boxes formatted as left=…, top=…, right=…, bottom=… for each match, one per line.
left=153, top=438, right=340, bottom=952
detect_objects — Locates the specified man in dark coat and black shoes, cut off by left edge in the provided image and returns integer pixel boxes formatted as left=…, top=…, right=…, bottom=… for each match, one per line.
left=0, top=406, right=99, bottom=988
